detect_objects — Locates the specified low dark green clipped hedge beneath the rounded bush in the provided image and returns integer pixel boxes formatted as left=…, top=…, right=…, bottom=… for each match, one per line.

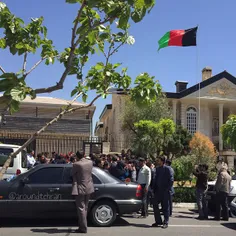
left=173, top=187, right=196, bottom=203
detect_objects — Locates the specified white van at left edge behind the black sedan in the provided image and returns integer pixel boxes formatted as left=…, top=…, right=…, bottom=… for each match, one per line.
left=0, top=144, right=28, bottom=179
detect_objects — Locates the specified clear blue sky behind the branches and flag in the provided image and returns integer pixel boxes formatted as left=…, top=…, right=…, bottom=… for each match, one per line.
left=0, top=0, right=236, bottom=132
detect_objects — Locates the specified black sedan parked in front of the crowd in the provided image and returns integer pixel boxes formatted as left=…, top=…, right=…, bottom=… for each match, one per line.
left=0, top=164, right=141, bottom=226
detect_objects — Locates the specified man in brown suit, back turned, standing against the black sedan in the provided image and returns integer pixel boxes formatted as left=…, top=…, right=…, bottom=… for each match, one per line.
left=72, top=152, right=94, bottom=233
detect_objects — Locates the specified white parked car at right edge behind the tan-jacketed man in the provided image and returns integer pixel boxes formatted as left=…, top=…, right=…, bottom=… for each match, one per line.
left=207, top=175, right=236, bottom=216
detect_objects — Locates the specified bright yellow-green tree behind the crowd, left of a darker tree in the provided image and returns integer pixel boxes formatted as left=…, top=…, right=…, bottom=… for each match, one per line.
left=134, top=119, right=175, bottom=157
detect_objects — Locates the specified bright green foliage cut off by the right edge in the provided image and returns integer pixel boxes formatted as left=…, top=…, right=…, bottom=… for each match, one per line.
left=220, top=115, right=236, bottom=150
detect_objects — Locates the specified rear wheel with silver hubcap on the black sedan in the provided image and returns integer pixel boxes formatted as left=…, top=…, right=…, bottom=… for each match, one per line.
left=91, top=201, right=116, bottom=227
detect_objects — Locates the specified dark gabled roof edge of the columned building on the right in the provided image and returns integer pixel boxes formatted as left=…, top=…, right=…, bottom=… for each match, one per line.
left=165, top=71, right=236, bottom=99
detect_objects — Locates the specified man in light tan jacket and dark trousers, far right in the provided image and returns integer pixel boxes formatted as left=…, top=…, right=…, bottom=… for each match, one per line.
left=215, top=166, right=232, bottom=221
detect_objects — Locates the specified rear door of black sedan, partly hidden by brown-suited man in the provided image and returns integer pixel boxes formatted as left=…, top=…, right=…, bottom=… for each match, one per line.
left=60, top=167, right=104, bottom=217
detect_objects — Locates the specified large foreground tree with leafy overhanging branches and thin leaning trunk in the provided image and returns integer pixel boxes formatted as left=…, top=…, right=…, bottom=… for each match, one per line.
left=0, top=0, right=161, bottom=179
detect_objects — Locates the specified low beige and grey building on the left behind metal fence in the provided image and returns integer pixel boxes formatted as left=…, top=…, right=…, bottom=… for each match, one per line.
left=0, top=97, right=95, bottom=154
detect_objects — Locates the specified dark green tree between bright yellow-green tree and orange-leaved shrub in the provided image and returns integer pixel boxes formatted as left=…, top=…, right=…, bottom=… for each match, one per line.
left=164, top=126, right=192, bottom=158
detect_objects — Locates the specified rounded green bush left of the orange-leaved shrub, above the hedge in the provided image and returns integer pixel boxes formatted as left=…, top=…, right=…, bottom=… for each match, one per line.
left=172, top=155, right=196, bottom=186
